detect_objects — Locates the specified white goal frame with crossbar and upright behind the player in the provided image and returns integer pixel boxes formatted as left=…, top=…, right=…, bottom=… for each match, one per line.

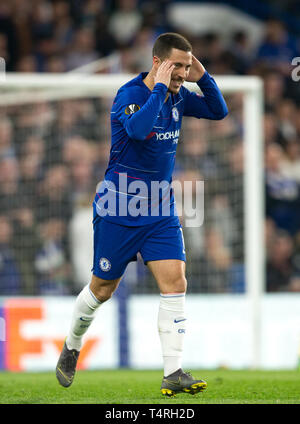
left=0, top=73, right=265, bottom=368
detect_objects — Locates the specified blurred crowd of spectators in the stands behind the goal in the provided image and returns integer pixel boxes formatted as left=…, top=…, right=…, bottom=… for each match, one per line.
left=0, top=0, right=300, bottom=295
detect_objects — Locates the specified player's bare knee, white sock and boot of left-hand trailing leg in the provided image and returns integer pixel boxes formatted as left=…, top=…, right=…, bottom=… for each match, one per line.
left=56, top=275, right=121, bottom=387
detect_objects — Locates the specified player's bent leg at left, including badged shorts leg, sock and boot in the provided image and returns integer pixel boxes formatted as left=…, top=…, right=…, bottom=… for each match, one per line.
left=56, top=216, right=138, bottom=387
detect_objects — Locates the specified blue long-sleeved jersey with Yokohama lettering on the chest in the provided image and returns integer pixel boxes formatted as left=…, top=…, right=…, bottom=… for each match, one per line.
left=95, top=72, right=228, bottom=226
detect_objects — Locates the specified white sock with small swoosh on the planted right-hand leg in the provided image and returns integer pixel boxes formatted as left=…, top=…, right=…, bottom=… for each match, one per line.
left=158, top=293, right=186, bottom=377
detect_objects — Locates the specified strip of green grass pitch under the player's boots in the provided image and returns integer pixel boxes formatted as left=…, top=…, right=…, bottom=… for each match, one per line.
left=0, top=369, right=300, bottom=406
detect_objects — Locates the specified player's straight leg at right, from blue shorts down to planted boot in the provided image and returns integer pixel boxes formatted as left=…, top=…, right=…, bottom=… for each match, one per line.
left=141, top=218, right=206, bottom=396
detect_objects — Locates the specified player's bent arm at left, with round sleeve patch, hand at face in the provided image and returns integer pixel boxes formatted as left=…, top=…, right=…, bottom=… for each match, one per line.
left=114, top=61, right=174, bottom=140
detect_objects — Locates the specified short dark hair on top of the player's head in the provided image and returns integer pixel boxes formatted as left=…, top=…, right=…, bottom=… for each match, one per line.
left=152, top=32, right=192, bottom=59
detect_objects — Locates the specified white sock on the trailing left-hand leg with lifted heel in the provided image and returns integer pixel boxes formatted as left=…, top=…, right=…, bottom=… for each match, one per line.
left=66, top=284, right=101, bottom=351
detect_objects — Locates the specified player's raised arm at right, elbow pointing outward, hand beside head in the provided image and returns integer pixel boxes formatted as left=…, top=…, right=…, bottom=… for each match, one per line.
left=183, top=56, right=228, bottom=120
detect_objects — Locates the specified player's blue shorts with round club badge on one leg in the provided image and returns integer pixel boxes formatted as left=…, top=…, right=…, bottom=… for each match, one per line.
left=92, top=213, right=186, bottom=280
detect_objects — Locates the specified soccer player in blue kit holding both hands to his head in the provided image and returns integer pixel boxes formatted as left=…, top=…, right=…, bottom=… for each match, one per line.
left=56, top=33, right=228, bottom=396
